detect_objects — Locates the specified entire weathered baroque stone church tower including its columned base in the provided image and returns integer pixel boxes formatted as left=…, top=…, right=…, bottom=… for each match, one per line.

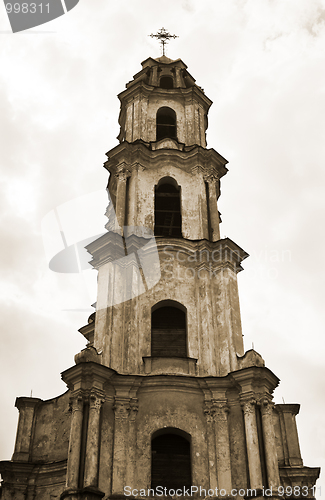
left=0, top=49, right=319, bottom=500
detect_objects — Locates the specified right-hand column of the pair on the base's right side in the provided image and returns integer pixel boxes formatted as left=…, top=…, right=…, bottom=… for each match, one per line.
left=261, top=399, right=280, bottom=490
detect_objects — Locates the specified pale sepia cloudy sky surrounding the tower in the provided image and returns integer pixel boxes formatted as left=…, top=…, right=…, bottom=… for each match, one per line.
left=0, top=0, right=325, bottom=491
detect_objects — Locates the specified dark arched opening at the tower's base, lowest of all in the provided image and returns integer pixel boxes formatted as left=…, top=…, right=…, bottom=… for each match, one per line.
left=151, top=428, right=192, bottom=490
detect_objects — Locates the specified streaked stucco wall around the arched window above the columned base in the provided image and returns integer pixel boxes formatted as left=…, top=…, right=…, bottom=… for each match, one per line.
left=94, top=239, right=244, bottom=376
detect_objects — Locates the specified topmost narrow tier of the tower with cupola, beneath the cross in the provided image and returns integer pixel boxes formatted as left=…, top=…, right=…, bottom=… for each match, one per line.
left=118, top=55, right=212, bottom=149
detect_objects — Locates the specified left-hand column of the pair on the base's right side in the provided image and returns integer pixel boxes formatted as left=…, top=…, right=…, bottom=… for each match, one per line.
left=242, top=400, right=263, bottom=490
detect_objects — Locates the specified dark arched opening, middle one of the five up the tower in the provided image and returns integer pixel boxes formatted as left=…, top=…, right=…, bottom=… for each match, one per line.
left=155, top=178, right=182, bottom=238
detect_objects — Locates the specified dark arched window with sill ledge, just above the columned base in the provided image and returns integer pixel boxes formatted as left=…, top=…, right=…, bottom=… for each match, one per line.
left=151, top=301, right=187, bottom=358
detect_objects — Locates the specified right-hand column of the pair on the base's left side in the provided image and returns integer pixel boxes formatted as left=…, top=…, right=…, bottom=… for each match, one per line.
left=84, top=393, right=104, bottom=487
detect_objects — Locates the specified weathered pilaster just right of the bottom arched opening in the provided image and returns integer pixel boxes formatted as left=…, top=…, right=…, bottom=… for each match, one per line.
left=213, top=401, right=232, bottom=495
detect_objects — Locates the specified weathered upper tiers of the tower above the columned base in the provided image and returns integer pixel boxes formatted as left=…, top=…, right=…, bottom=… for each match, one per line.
left=88, top=51, right=247, bottom=376
